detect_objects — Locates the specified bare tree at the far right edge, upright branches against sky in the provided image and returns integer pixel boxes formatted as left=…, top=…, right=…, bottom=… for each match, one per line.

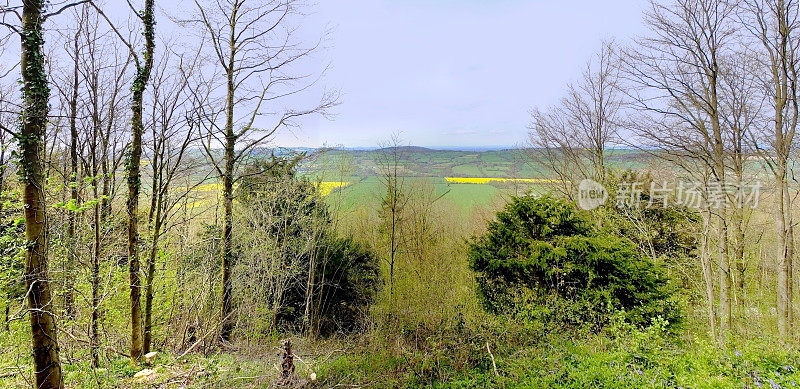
left=740, top=0, right=800, bottom=338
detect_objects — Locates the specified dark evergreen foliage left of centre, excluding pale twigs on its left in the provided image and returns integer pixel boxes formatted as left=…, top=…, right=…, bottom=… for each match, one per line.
left=240, top=156, right=379, bottom=335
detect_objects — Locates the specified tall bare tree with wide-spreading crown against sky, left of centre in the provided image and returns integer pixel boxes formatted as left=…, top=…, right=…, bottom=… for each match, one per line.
left=192, top=0, right=336, bottom=340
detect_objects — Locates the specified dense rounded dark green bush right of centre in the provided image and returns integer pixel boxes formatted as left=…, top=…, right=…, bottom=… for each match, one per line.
left=468, top=196, right=679, bottom=329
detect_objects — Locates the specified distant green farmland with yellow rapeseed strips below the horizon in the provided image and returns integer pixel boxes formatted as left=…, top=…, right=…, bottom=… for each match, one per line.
left=302, top=147, right=648, bottom=212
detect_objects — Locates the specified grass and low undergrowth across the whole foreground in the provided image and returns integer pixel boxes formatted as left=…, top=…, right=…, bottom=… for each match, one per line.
left=6, top=308, right=800, bottom=389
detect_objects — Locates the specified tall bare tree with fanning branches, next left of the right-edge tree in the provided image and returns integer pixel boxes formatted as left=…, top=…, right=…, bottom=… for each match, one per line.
left=625, top=0, right=735, bottom=337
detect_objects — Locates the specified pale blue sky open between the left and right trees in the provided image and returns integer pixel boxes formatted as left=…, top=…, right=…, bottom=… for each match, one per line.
left=156, top=0, right=647, bottom=147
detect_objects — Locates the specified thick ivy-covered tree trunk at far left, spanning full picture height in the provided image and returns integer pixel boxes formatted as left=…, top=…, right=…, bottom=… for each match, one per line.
left=18, top=0, right=64, bottom=389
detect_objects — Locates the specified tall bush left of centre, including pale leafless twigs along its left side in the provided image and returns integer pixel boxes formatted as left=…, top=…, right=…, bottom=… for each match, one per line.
left=234, top=158, right=379, bottom=335
